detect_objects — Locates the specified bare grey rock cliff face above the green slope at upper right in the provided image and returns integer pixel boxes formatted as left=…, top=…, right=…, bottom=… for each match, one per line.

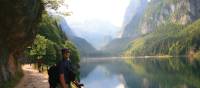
left=139, top=0, right=200, bottom=34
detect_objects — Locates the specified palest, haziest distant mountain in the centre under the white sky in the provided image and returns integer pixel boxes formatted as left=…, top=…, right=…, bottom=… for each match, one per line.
left=70, top=19, right=119, bottom=49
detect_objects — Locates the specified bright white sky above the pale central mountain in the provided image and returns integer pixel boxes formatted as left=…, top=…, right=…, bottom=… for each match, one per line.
left=66, top=0, right=130, bottom=27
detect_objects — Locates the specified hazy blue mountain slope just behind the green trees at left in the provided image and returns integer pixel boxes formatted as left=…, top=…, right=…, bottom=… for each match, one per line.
left=59, top=16, right=97, bottom=56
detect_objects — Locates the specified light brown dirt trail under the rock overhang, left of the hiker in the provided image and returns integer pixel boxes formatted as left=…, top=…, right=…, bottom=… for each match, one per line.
left=15, top=65, right=49, bottom=88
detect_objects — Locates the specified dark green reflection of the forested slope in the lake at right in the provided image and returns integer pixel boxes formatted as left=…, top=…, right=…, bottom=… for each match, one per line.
left=133, top=58, right=200, bottom=88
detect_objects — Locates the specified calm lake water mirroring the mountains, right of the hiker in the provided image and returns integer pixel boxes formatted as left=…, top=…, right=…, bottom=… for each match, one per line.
left=81, top=58, right=200, bottom=88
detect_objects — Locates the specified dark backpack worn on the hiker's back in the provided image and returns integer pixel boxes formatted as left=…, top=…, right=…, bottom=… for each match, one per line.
left=48, top=65, right=59, bottom=88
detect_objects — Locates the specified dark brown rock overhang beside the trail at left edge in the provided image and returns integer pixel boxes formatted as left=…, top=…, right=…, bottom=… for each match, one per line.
left=0, top=0, right=43, bottom=87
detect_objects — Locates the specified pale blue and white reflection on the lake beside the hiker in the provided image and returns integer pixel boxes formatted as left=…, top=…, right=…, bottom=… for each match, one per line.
left=81, top=65, right=125, bottom=88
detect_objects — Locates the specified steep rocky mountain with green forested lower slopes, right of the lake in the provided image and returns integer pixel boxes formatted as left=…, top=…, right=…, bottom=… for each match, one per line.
left=105, top=0, right=200, bottom=55
